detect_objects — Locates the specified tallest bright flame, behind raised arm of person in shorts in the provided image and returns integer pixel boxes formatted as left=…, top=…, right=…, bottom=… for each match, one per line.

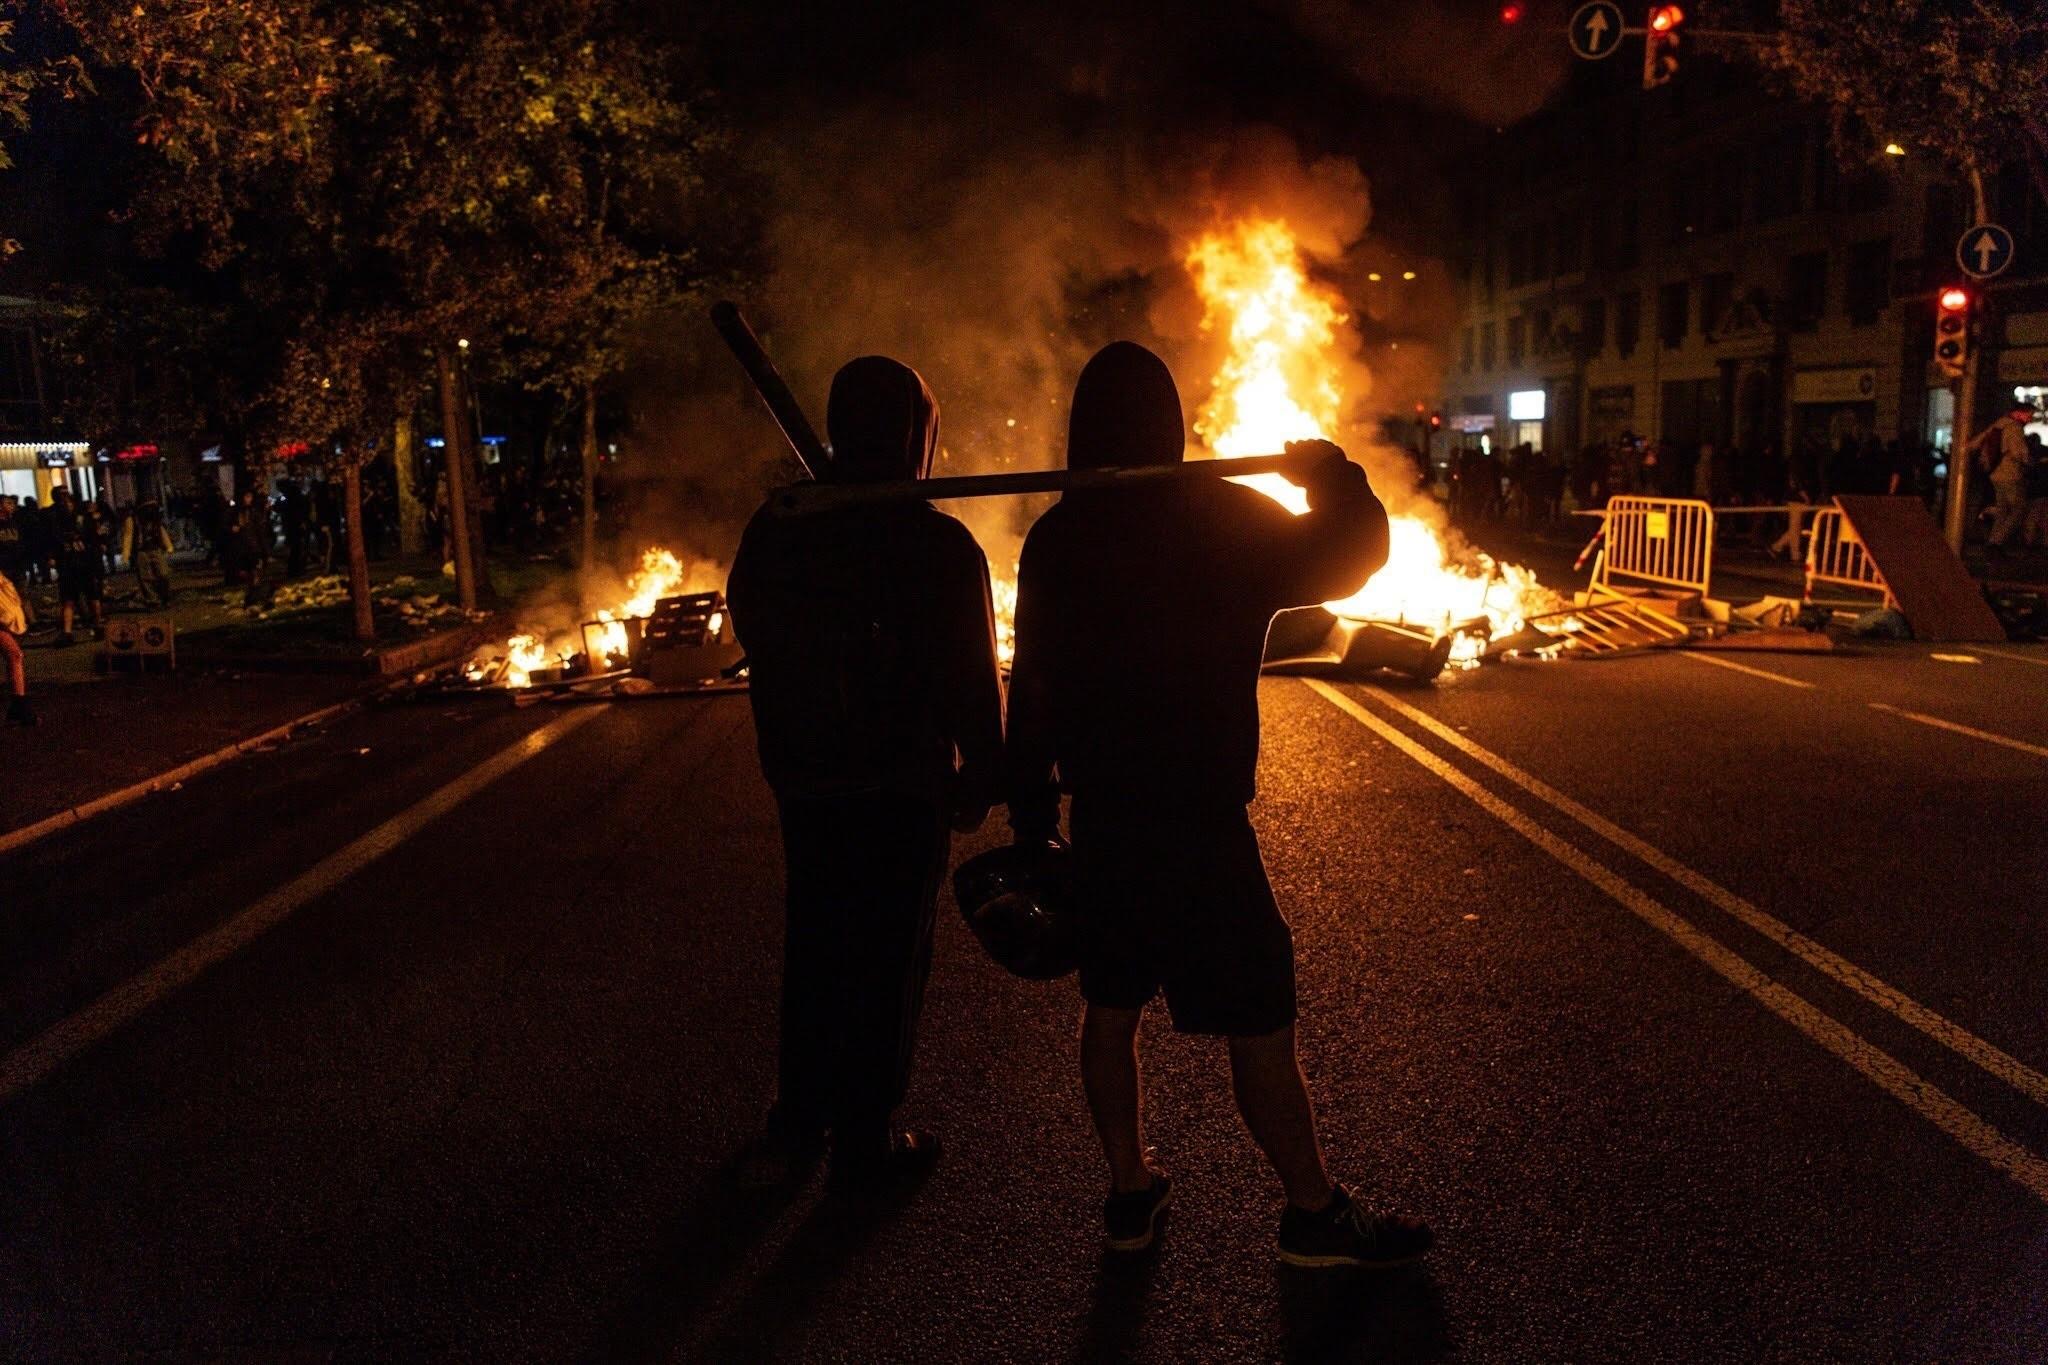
left=1184, top=219, right=1554, bottom=661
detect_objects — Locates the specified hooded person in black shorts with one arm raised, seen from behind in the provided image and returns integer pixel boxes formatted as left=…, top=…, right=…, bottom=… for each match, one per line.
left=1008, top=342, right=1430, bottom=1265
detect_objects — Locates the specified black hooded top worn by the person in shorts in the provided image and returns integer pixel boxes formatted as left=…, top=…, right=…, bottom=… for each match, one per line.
left=1008, top=342, right=1386, bottom=839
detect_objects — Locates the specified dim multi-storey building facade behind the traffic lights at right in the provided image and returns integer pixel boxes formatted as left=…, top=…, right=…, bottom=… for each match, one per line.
left=1442, top=63, right=2048, bottom=493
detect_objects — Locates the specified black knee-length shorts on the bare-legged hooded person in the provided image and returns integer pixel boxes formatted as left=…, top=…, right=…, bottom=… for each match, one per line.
left=1069, top=794, right=1294, bottom=1038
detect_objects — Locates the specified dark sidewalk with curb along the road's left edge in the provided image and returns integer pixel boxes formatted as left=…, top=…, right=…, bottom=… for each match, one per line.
left=0, top=555, right=552, bottom=833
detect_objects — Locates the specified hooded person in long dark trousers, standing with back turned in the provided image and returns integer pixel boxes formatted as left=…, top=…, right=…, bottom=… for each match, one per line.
left=727, top=356, right=1001, bottom=1189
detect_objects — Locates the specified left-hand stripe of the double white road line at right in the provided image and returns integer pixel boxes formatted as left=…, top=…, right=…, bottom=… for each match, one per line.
left=1303, top=677, right=2048, bottom=1203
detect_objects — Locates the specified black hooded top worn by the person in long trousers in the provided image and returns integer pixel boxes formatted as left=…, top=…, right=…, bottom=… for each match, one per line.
left=725, top=356, right=1004, bottom=804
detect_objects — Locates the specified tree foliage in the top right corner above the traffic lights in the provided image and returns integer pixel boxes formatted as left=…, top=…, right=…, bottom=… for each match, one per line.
left=1757, top=0, right=2048, bottom=198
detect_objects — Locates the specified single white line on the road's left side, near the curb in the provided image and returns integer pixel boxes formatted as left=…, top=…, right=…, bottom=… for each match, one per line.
left=0, top=706, right=606, bottom=1103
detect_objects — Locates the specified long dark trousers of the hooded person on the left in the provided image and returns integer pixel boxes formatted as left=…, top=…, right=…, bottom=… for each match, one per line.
left=776, top=792, right=950, bottom=1150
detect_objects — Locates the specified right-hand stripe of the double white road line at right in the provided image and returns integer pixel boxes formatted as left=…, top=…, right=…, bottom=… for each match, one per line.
left=1368, top=688, right=2048, bottom=1105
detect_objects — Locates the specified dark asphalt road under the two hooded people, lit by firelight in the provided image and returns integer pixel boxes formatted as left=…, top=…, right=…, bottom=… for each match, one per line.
left=0, top=645, right=2048, bottom=1361
